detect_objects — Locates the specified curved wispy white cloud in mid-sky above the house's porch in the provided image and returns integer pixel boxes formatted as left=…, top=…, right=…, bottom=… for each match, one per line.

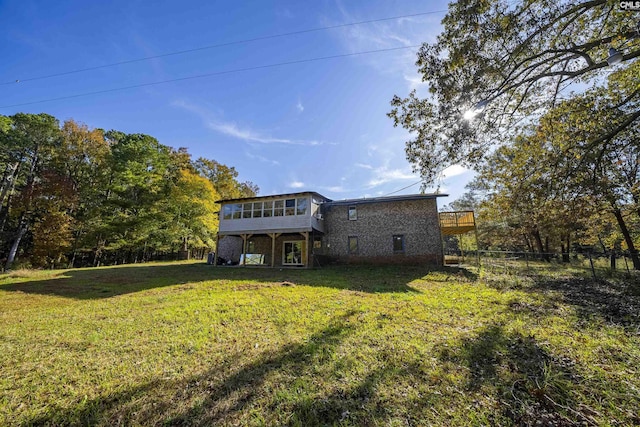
left=171, top=101, right=328, bottom=146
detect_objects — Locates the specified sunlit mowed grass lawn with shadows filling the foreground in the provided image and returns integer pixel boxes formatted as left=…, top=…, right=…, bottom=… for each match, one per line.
left=0, top=263, right=640, bottom=426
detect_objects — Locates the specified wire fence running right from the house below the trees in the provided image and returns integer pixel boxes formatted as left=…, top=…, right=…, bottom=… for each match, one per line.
left=445, top=251, right=637, bottom=279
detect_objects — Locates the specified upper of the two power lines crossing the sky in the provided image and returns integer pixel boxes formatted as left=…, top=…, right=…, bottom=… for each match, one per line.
left=0, top=10, right=446, bottom=86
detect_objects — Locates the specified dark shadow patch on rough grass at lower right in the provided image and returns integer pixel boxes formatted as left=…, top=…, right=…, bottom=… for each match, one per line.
left=440, top=324, right=594, bottom=426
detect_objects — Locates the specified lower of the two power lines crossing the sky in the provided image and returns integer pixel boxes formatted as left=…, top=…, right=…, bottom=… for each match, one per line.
left=0, top=45, right=420, bottom=109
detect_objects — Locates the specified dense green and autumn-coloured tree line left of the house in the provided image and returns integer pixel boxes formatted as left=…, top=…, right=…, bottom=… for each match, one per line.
left=0, top=113, right=258, bottom=270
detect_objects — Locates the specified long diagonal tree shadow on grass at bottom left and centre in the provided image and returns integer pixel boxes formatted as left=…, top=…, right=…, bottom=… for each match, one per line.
left=23, top=311, right=400, bottom=426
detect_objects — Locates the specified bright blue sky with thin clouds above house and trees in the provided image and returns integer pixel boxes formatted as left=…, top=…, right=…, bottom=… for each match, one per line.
left=0, top=0, right=472, bottom=204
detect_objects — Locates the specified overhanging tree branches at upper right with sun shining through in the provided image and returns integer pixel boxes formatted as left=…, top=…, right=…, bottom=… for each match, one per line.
left=389, top=0, right=640, bottom=183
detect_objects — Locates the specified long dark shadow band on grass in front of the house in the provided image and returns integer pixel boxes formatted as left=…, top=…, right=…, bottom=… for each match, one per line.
left=0, top=264, right=475, bottom=299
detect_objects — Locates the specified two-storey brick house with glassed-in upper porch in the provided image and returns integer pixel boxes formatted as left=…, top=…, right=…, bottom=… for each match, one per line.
left=216, top=192, right=444, bottom=267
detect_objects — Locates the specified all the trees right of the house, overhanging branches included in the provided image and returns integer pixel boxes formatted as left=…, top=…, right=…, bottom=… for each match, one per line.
left=389, top=0, right=640, bottom=269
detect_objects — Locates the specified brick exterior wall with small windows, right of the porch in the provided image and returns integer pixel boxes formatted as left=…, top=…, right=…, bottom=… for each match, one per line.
left=317, top=198, right=442, bottom=264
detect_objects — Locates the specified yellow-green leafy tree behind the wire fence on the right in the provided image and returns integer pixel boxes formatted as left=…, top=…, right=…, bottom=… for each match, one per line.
left=464, top=78, right=640, bottom=269
